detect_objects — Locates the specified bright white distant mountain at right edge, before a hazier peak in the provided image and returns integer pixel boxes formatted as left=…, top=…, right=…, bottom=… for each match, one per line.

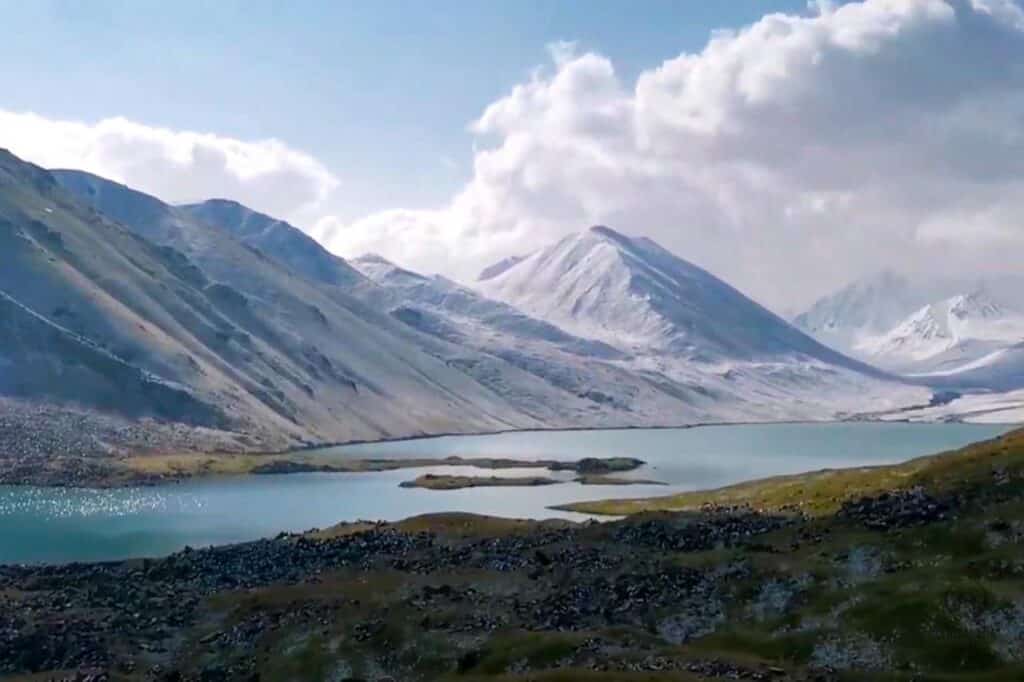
left=856, top=292, right=1024, bottom=374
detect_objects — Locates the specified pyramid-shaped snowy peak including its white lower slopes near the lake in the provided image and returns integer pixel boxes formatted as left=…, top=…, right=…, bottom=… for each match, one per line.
left=475, top=226, right=929, bottom=419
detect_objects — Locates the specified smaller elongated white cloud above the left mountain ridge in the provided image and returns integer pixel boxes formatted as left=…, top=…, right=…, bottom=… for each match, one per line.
left=0, top=111, right=338, bottom=218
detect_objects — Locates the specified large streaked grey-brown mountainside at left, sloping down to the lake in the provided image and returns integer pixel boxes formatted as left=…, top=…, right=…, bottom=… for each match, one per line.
left=0, top=154, right=561, bottom=464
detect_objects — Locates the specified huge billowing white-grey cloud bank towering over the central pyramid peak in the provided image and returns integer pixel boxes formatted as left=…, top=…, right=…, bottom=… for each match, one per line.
left=315, top=0, right=1024, bottom=307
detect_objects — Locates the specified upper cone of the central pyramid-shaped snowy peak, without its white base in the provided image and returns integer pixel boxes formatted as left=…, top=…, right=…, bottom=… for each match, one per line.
left=478, top=226, right=870, bottom=372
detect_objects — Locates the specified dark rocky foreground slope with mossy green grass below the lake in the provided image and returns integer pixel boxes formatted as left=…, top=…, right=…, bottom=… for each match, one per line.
left=0, top=431, right=1024, bottom=681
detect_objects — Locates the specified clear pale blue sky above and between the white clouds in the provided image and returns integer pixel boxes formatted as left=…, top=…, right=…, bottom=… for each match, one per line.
left=0, top=0, right=806, bottom=219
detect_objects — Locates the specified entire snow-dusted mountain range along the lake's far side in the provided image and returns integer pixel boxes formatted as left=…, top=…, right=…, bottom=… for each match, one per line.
left=6, top=145, right=1017, bottom=458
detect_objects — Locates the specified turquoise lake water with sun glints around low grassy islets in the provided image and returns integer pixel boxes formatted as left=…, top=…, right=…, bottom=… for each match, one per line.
left=0, top=423, right=1010, bottom=563
